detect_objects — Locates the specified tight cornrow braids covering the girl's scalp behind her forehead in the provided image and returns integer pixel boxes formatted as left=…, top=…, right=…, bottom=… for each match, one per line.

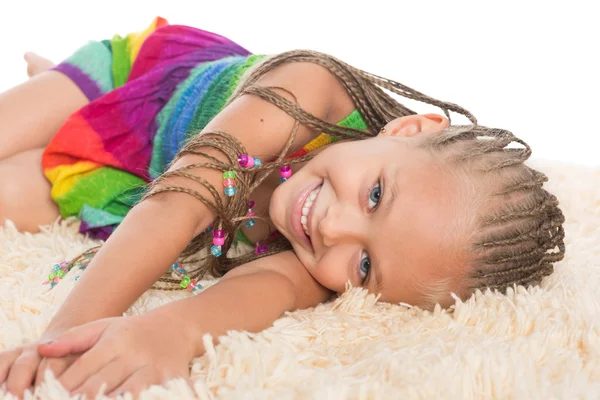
left=422, top=125, right=565, bottom=304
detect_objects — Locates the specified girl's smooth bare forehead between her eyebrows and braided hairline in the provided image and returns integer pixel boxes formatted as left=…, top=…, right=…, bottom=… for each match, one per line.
left=375, top=149, right=466, bottom=303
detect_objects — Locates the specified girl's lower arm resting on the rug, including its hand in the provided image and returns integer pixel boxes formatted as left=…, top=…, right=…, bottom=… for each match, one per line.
left=39, top=251, right=332, bottom=395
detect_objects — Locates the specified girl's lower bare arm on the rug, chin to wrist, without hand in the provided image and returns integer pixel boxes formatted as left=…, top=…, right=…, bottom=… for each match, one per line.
left=147, top=251, right=333, bottom=356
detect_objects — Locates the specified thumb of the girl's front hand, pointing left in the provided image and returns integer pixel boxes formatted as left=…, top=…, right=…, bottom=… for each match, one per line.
left=37, top=320, right=108, bottom=357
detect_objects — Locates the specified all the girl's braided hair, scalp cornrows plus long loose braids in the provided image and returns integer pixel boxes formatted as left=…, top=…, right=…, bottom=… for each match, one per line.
left=67, top=50, right=565, bottom=303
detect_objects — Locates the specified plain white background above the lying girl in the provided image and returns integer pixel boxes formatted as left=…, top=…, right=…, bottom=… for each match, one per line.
left=0, top=0, right=600, bottom=166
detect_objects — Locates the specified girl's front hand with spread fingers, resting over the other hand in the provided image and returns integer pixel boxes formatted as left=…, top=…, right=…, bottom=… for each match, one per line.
left=38, top=314, right=195, bottom=398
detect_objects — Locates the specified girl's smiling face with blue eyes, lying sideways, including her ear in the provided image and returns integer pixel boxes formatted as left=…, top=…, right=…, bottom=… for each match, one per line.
left=269, top=116, right=468, bottom=304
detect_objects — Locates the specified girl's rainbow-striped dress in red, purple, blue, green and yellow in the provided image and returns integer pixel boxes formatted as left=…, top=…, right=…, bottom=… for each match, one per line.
left=42, top=18, right=367, bottom=239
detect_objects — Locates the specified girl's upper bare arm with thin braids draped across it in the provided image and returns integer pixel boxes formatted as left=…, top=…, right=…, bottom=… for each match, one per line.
left=44, top=63, right=339, bottom=338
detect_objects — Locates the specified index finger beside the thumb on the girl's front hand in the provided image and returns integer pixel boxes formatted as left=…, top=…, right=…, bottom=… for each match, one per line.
left=58, top=345, right=118, bottom=391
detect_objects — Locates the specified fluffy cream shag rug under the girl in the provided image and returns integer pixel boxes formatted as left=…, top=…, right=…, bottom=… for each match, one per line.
left=0, top=160, right=600, bottom=399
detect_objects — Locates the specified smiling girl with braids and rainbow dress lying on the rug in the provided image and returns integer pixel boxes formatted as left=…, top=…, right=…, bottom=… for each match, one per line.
left=0, top=18, right=564, bottom=395
